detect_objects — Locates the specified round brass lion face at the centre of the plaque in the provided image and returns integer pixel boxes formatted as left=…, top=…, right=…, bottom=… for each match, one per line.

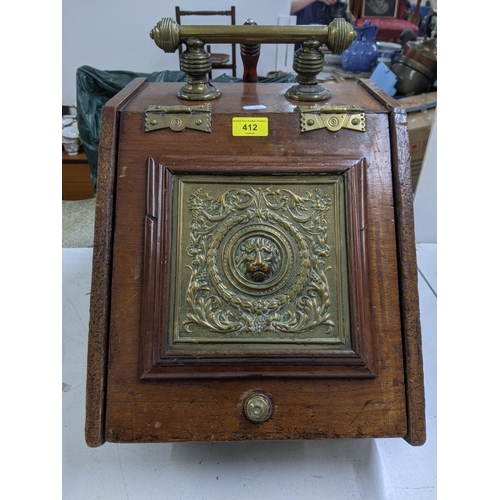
left=235, top=236, right=281, bottom=283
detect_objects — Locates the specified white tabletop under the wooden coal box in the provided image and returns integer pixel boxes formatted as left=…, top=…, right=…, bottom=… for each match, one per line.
left=62, top=245, right=436, bottom=500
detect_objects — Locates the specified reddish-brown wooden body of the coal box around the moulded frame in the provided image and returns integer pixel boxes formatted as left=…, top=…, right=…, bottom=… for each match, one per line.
left=86, top=79, right=425, bottom=446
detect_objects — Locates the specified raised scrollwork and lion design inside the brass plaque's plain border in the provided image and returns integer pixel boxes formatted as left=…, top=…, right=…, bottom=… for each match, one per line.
left=183, top=187, right=335, bottom=337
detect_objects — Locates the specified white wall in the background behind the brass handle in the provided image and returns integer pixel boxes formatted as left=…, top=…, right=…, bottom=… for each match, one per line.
left=62, top=0, right=291, bottom=106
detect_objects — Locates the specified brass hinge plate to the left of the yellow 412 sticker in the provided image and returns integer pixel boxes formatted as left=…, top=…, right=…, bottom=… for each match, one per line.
left=145, top=104, right=212, bottom=132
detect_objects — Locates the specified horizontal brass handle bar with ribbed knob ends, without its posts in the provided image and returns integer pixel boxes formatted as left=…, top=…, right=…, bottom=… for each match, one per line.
left=149, top=17, right=356, bottom=54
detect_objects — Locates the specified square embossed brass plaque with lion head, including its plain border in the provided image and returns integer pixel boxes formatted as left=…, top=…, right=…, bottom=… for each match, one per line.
left=167, top=174, right=351, bottom=350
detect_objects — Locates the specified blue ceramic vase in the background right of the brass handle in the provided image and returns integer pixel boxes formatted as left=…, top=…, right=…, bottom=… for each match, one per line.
left=341, top=20, right=379, bottom=73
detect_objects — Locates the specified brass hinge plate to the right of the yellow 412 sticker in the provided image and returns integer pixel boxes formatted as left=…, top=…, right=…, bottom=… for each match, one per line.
left=298, top=104, right=365, bottom=132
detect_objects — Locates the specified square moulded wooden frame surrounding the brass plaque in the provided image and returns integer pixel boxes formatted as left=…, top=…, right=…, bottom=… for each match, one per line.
left=140, top=157, right=376, bottom=380
